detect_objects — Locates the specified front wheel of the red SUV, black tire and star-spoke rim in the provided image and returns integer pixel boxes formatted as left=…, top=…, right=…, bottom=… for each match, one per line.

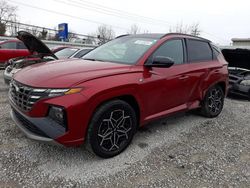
left=88, top=100, right=137, bottom=158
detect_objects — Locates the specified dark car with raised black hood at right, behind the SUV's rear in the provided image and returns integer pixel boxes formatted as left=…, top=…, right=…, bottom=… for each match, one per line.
left=222, top=48, right=250, bottom=100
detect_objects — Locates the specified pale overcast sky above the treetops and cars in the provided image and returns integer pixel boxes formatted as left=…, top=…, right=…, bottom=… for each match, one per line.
left=8, top=0, right=250, bottom=45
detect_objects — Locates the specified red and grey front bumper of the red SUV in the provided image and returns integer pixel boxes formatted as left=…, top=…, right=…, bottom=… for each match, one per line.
left=9, top=87, right=91, bottom=146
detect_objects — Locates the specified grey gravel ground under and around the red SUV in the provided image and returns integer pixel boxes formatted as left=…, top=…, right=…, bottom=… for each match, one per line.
left=0, top=71, right=250, bottom=187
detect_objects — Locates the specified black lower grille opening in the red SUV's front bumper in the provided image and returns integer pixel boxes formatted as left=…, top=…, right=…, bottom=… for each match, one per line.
left=12, top=109, right=49, bottom=138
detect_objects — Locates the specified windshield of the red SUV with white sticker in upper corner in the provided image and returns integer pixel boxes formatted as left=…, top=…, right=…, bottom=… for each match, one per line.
left=83, top=36, right=157, bottom=64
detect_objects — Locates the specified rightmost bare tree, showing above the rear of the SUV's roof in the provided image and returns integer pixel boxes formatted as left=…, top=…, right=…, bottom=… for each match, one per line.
left=169, top=22, right=201, bottom=36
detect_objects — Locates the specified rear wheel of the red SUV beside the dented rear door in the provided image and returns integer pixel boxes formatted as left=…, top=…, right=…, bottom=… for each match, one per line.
left=200, top=85, right=225, bottom=118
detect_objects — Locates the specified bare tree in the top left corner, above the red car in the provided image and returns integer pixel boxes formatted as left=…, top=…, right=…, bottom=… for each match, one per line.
left=0, top=0, right=17, bottom=35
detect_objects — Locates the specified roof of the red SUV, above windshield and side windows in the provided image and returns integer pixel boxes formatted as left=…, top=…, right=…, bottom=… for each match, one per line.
left=116, top=33, right=211, bottom=42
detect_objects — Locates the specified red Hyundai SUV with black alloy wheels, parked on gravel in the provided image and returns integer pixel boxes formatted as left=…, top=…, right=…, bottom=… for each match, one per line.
left=9, top=34, right=228, bottom=158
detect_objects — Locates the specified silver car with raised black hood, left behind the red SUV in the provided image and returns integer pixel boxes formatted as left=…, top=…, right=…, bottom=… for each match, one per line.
left=4, top=31, right=92, bottom=84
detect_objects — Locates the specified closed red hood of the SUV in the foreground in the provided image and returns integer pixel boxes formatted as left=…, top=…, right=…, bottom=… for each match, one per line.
left=14, top=59, right=131, bottom=88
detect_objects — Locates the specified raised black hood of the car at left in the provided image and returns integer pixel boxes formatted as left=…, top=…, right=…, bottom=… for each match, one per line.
left=17, top=31, right=58, bottom=59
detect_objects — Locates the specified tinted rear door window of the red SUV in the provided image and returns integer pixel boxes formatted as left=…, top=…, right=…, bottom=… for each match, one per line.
left=188, top=39, right=213, bottom=62
